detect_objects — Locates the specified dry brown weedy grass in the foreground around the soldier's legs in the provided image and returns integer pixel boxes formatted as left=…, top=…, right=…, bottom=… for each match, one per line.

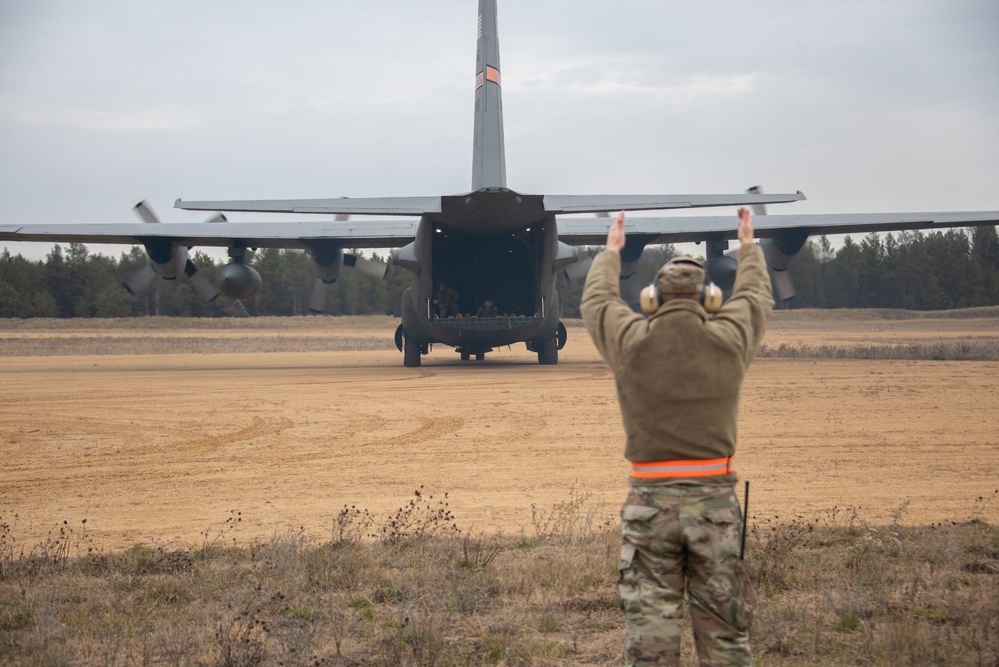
left=0, top=492, right=999, bottom=665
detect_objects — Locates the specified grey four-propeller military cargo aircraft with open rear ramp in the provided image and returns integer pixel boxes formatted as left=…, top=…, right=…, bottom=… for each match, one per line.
left=0, top=0, right=999, bottom=367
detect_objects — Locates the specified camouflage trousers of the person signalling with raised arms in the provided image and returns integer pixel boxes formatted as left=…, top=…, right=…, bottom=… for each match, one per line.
left=617, top=481, right=756, bottom=666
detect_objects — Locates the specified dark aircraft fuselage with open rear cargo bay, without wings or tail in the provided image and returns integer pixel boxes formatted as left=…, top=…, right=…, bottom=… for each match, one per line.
left=395, top=188, right=559, bottom=366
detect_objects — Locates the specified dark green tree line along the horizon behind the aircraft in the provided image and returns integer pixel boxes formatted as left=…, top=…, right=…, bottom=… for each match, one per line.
left=0, top=227, right=999, bottom=318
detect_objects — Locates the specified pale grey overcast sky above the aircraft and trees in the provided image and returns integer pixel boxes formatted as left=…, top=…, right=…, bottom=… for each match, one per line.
left=0, top=0, right=999, bottom=258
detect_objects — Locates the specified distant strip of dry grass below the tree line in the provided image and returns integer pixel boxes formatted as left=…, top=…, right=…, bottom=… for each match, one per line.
left=0, top=307, right=999, bottom=361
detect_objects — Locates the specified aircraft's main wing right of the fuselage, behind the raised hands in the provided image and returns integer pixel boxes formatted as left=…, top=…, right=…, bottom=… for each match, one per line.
left=558, top=211, right=999, bottom=245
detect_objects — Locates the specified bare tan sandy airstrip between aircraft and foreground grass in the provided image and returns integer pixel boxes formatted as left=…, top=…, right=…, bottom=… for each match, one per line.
left=0, top=318, right=999, bottom=549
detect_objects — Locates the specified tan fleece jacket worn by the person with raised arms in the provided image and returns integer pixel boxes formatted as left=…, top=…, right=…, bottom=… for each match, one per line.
left=580, top=243, right=773, bottom=484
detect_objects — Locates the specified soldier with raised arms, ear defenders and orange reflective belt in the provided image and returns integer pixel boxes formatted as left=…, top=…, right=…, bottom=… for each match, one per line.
left=580, top=209, right=773, bottom=665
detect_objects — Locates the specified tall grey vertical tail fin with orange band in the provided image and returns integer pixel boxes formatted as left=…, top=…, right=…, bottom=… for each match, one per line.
left=472, top=0, right=506, bottom=190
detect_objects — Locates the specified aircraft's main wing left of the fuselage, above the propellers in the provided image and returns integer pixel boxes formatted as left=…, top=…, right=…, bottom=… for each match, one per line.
left=0, top=220, right=419, bottom=248
